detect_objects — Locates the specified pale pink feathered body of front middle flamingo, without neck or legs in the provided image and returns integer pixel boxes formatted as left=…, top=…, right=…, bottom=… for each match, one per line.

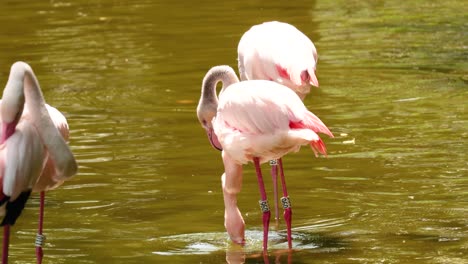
left=213, top=80, right=332, bottom=164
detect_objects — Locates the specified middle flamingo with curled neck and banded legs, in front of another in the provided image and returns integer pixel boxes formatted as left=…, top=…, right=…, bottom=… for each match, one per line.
left=197, top=66, right=333, bottom=252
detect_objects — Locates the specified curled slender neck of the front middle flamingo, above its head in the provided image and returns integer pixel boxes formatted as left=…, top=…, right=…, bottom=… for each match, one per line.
left=200, top=65, right=239, bottom=107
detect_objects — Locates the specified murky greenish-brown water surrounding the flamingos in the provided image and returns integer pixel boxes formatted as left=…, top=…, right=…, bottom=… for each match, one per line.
left=0, top=0, right=468, bottom=263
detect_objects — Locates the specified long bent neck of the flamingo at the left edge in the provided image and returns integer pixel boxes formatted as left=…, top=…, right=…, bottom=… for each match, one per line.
left=4, top=62, right=77, bottom=178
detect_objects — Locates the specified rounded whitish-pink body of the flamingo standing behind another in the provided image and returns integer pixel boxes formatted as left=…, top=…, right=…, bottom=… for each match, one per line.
left=237, top=21, right=319, bottom=99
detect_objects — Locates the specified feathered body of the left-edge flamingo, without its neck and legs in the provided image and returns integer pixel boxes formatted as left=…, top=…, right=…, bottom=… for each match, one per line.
left=0, top=92, right=69, bottom=225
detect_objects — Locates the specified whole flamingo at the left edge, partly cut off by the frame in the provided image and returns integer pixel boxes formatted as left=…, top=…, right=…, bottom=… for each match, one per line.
left=0, top=62, right=78, bottom=263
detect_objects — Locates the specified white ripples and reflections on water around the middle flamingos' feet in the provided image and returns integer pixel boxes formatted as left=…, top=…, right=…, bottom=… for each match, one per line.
left=149, top=226, right=347, bottom=263
